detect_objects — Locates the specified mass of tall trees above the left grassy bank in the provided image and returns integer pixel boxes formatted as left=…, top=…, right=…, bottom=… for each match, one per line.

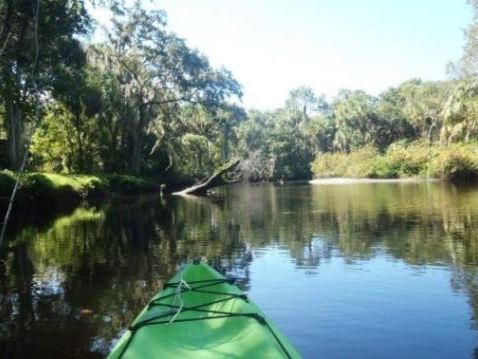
left=0, top=0, right=241, bottom=183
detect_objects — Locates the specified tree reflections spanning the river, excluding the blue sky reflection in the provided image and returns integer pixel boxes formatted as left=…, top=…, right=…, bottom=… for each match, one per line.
left=0, top=183, right=478, bottom=358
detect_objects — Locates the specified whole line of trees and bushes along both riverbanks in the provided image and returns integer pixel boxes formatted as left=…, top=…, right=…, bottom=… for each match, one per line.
left=0, top=0, right=478, bottom=183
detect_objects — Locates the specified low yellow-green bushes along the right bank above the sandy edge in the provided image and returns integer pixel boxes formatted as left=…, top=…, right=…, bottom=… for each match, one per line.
left=312, top=143, right=478, bottom=182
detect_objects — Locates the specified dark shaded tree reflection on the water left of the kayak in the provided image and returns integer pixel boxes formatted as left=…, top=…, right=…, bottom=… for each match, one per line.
left=0, top=197, right=252, bottom=358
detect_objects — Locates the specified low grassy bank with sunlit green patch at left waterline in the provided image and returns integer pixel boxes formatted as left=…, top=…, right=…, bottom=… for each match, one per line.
left=0, top=171, right=159, bottom=205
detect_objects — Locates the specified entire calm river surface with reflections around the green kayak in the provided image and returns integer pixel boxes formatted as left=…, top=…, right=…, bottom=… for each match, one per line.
left=0, top=183, right=478, bottom=358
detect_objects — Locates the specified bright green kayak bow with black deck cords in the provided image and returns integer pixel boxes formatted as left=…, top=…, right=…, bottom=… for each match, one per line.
left=109, top=263, right=300, bottom=359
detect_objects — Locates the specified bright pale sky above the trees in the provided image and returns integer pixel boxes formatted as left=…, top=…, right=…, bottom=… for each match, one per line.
left=88, top=0, right=472, bottom=110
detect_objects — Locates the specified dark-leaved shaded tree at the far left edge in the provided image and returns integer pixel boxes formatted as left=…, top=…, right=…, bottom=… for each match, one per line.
left=0, top=0, right=91, bottom=169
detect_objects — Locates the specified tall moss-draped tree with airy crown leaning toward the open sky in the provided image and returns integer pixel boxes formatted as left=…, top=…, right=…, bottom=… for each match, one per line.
left=98, top=2, right=241, bottom=174
